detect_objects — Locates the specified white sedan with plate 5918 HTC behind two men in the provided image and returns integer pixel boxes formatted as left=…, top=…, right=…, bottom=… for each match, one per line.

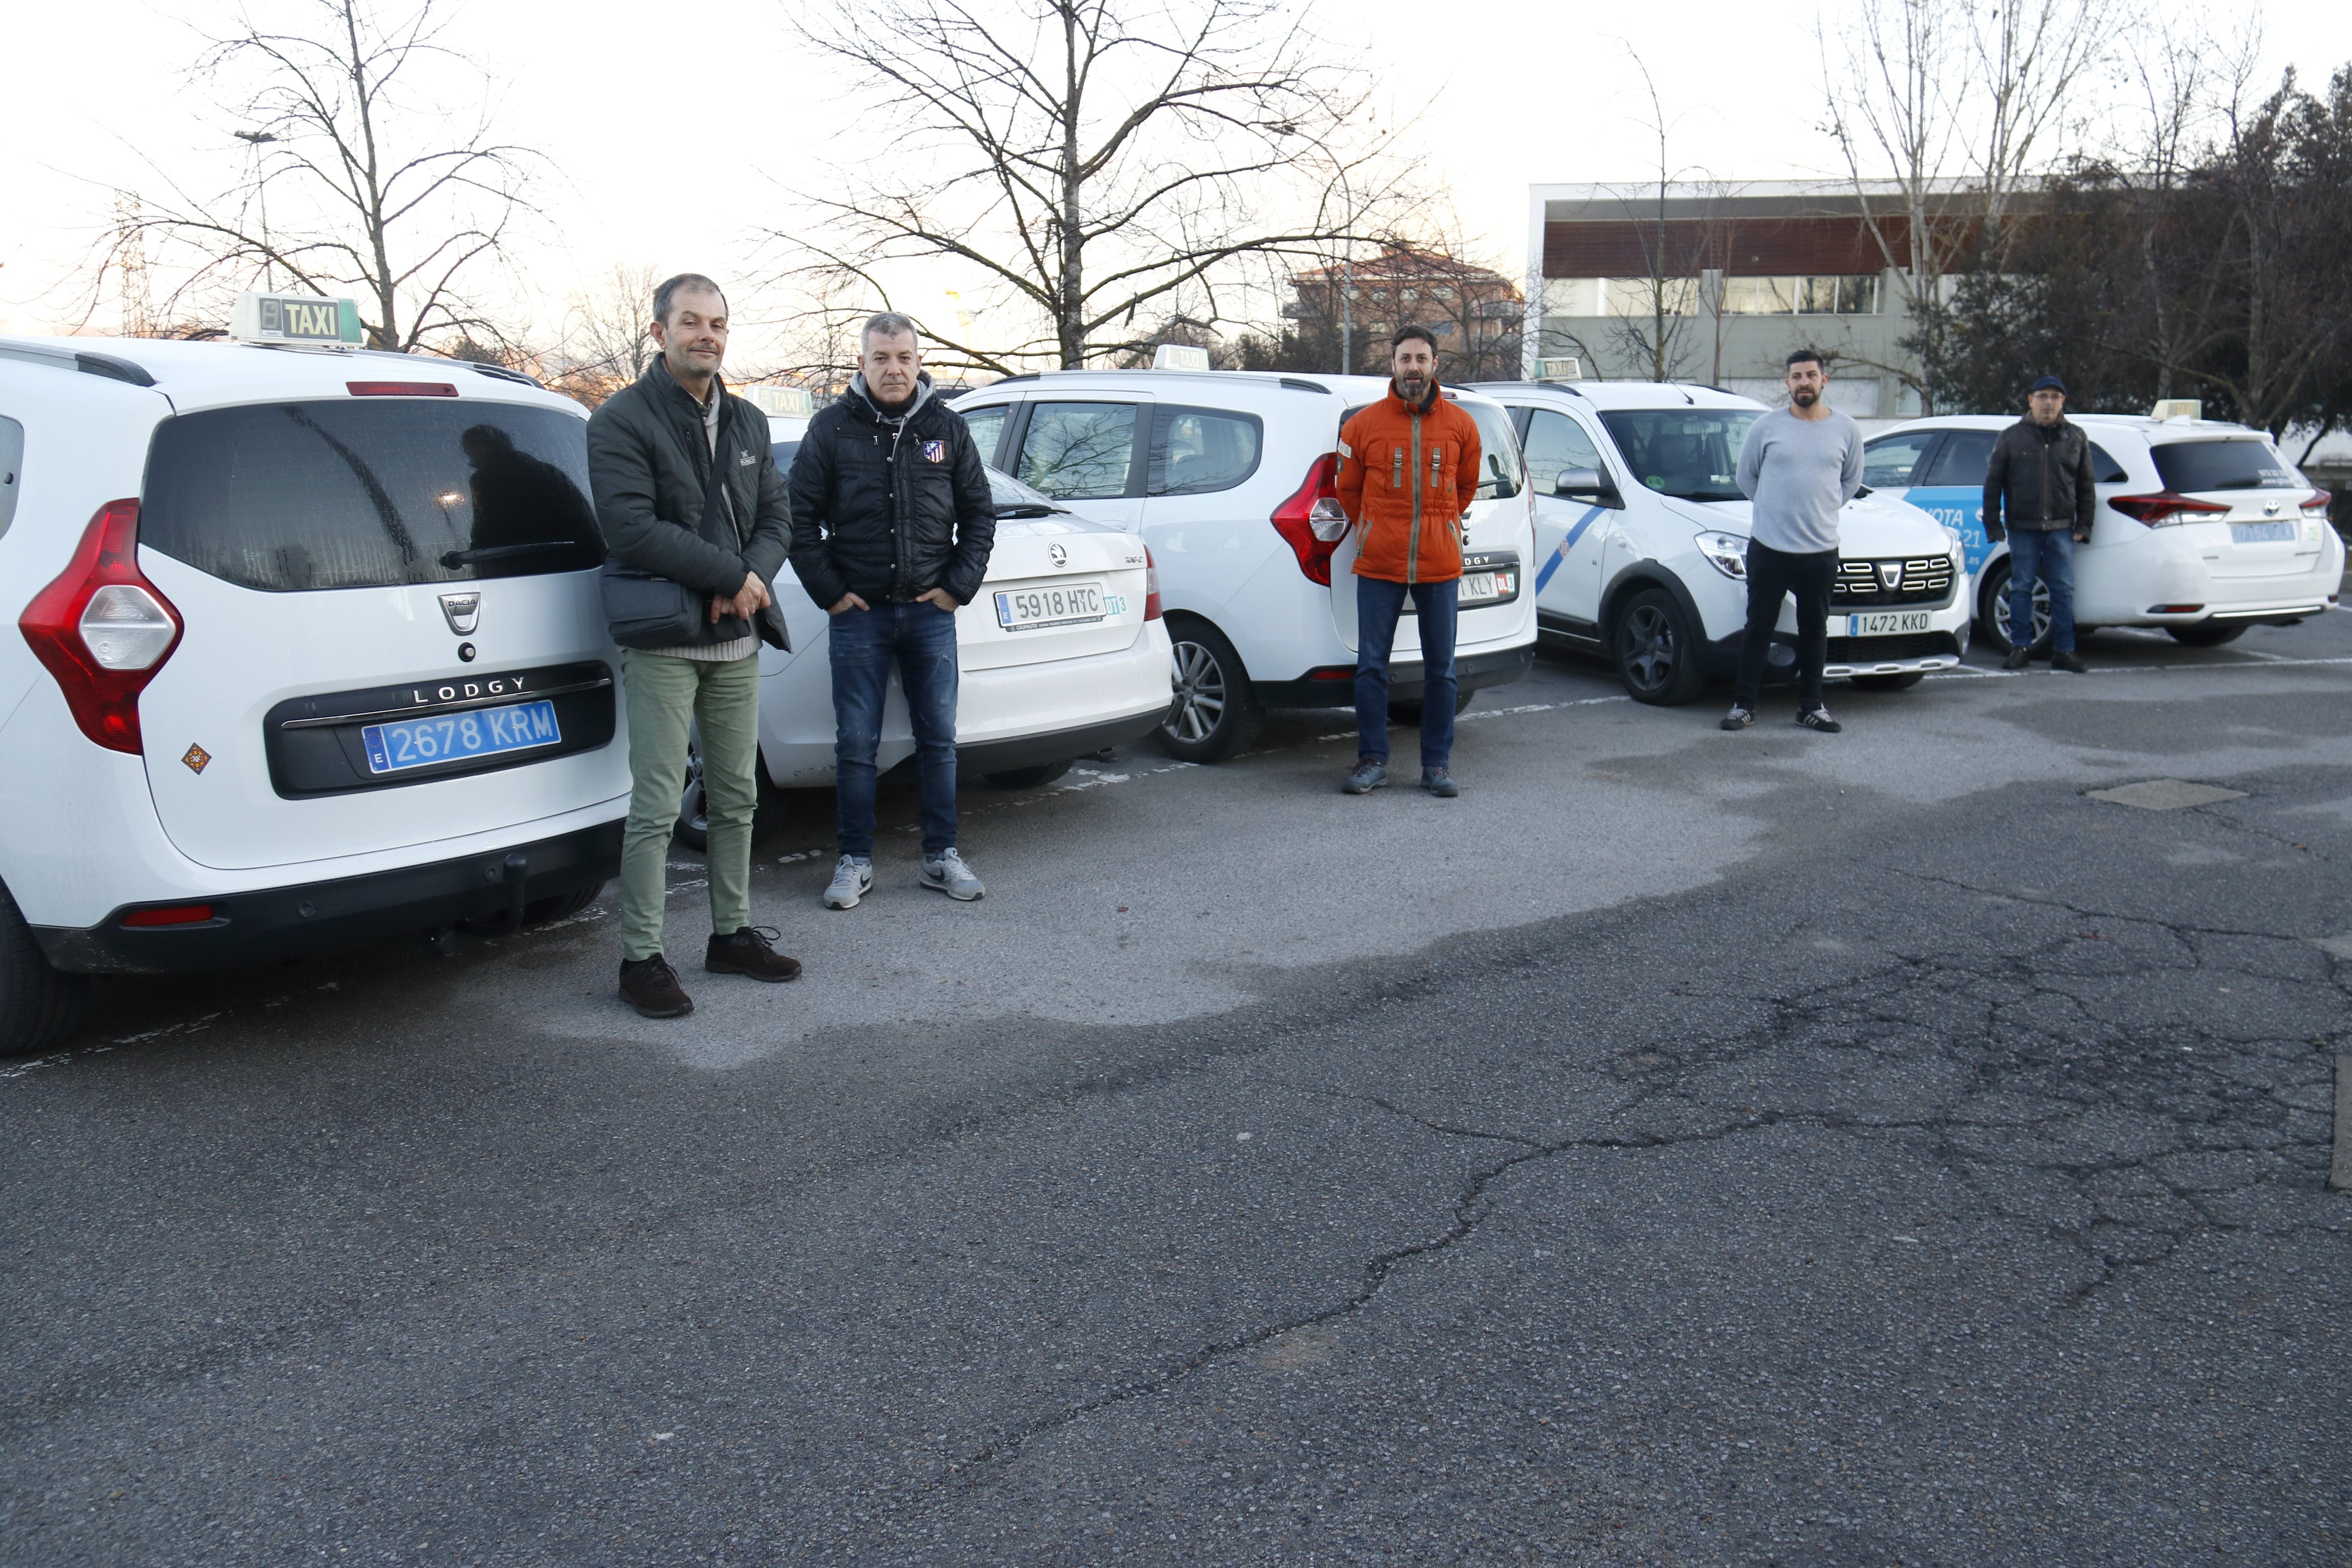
left=677, top=434, right=1171, bottom=848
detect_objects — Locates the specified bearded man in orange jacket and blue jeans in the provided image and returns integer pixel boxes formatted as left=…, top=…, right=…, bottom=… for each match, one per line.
left=1338, top=327, right=1479, bottom=797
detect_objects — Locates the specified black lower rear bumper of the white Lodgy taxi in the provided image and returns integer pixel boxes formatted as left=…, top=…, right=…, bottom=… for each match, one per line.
left=33, top=820, right=621, bottom=973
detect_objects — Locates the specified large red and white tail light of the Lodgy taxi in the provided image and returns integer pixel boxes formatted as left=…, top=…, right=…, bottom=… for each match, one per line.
left=17, top=500, right=181, bottom=755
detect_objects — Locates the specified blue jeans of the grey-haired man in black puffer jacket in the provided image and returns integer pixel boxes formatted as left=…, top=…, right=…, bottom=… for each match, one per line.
left=828, top=604, right=957, bottom=858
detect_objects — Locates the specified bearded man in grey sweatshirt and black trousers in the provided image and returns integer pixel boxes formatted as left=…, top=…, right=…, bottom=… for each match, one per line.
left=1724, top=348, right=1863, bottom=736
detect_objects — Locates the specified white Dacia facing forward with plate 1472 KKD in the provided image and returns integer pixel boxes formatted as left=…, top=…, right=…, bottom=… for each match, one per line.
left=1479, top=381, right=1969, bottom=703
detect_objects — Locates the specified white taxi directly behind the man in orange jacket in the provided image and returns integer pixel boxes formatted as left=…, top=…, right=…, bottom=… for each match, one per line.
left=955, top=364, right=1536, bottom=761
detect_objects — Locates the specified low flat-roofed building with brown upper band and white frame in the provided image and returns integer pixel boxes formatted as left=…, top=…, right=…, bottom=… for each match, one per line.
left=1522, top=181, right=1966, bottom=418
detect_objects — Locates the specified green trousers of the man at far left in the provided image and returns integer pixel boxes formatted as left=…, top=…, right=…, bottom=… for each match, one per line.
left=621, top=649, right=760, bottom=959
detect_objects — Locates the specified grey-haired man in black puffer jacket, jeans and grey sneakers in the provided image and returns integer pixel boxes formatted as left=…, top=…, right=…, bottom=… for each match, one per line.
left=790, top=311, right=997, bottom=910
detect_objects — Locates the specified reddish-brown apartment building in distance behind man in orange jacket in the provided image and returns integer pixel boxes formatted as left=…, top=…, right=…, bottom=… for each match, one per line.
left=1282, top=244, right=1527, bottom=381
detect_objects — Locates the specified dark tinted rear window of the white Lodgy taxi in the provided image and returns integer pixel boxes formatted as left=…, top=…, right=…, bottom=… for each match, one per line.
left=139, top=400, right=605, bottom=592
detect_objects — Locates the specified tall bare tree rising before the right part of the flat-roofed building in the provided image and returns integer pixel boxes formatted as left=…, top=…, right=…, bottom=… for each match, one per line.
left=1818, top=0, right=2124, bottom=411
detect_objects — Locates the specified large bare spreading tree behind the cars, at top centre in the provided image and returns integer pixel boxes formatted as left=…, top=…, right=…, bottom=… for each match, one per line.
left=776, top=0, right=1395, bottom=372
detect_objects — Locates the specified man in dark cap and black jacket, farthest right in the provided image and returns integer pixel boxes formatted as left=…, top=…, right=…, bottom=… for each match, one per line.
left=1985, top=376, right=2098, bottom=674
